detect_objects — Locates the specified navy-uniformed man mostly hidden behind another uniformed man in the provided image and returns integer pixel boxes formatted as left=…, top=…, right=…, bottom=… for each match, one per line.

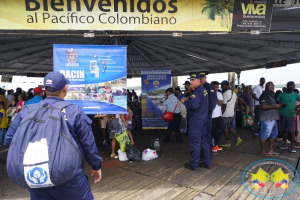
left=199, top=72, right=218, bottom=153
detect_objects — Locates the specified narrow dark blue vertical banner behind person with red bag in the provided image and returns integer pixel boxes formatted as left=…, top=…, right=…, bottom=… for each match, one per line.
left=141, top=70, right=171, bottom=129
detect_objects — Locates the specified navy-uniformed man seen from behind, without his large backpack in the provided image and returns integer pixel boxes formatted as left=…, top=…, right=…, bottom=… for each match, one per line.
left=5, top=72, right=102, bottom=200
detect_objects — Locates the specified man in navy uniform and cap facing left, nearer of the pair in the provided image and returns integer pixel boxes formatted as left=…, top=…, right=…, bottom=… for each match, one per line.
left=181, top=73, right=212, bottom=171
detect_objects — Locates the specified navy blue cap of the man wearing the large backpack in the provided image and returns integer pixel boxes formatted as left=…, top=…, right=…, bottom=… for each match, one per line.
left=44, top=72, right=70, bottom=92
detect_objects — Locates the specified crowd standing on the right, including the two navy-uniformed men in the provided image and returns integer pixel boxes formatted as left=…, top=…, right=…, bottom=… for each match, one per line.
left=162, top=72, right=300, bottom=171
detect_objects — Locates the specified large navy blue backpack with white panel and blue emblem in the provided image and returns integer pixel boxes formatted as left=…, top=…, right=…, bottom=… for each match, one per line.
left=7, top=101, right=83, bottom=188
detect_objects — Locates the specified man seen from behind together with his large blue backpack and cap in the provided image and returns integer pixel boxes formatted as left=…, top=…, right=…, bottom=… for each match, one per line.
left=5, top=72, right=102, bottom=199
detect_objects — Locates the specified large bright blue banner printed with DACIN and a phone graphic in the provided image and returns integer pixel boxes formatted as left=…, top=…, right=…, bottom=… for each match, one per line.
left=53, top=44, right=127, bottom=115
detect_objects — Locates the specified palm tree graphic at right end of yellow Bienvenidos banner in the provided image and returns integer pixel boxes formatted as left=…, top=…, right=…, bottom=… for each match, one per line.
left=201, top=0, right=234, bottom=27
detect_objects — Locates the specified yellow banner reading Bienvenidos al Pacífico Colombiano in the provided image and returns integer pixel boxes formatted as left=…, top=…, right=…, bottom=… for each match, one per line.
left=0, top=0, right=234, bottom=31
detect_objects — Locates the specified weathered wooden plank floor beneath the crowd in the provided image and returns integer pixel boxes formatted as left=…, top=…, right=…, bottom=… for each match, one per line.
left=0, top=127, right=300, bottom=200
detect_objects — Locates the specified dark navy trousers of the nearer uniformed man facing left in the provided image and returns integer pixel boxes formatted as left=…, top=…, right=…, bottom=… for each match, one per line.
left=189, top=123, right=212, bottom=168
